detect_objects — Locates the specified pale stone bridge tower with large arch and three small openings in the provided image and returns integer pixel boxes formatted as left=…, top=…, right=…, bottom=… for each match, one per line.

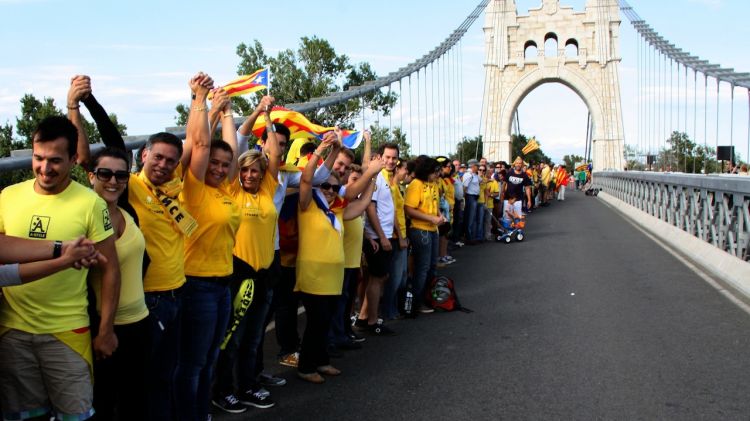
left=482, top=0, right=624, bottom=170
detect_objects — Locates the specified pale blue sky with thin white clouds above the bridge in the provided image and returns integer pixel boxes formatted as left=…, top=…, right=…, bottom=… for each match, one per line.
left=0, top=0, right=750, bottom=160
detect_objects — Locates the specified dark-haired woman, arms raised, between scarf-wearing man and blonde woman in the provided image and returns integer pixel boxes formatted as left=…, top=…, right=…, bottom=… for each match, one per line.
left=176, top=73, right=240, bottom=421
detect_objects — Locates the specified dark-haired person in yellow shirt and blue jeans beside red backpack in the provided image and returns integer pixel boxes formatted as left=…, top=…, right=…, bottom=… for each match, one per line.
left=404, top=155, right=446, bottom=313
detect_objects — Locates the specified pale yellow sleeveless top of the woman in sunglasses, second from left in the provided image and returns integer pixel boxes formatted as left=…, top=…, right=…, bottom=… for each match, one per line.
left=91, top=209, right=148, bottom=325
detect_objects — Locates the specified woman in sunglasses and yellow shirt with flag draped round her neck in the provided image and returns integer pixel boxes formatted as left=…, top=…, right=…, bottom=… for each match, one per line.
left=295, top=130, right=383, bottom=383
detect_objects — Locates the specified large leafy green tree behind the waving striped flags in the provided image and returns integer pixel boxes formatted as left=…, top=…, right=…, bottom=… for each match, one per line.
left=175, top=36, right=397, bottom=128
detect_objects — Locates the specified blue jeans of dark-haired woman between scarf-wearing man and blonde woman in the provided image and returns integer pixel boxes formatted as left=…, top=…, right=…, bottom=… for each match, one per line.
left=177, top=276, right=231, bottom=421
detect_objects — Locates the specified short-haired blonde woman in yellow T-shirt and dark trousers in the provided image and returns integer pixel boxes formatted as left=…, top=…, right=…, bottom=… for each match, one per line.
left=212, top=97, right=281, bottom=413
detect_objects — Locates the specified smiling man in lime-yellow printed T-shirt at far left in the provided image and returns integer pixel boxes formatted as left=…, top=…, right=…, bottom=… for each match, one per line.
left=0, top=116, right=120, bottom=419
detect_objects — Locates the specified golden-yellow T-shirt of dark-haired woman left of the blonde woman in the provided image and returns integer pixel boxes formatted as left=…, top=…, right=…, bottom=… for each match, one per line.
left=182, top=170, right=240, bottom=277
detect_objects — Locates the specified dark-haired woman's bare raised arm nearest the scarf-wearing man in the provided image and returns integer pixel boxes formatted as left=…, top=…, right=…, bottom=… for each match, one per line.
left=182, top=73, right=213, bottom=181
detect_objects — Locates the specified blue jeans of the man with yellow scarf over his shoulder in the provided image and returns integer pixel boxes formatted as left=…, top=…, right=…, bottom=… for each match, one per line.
left=143, top=288, right=182, bottom=421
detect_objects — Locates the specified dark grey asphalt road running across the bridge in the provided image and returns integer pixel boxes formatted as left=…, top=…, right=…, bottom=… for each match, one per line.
left=220, top=192, right=750, bottom=420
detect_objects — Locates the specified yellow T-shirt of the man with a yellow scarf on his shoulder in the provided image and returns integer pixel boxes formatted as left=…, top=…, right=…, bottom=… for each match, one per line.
left=128, top=174, right=185, bottom=292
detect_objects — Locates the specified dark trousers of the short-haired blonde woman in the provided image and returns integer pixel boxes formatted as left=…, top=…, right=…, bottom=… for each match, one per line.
left=215, top=278, right=273, bottom=397
